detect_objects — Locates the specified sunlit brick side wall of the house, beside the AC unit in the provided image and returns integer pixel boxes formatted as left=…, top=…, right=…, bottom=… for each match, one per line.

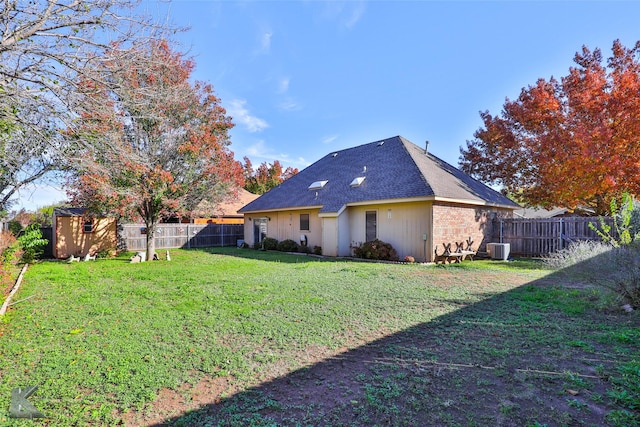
left=431, top=203, right=513, bottom=255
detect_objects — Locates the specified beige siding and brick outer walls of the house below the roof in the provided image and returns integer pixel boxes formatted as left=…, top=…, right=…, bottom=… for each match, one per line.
left=245, top=202, right=511, bottom=262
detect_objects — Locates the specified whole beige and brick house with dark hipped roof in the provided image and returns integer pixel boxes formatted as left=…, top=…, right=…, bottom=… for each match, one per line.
left=239, top=136, right=520, bottom=261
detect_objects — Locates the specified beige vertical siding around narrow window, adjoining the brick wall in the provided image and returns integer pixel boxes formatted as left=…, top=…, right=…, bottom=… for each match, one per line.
left=348, top=202, right=431, bottom=261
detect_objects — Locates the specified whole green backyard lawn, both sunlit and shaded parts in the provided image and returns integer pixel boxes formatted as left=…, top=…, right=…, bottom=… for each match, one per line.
left=0, top=248, right=640, bottom=426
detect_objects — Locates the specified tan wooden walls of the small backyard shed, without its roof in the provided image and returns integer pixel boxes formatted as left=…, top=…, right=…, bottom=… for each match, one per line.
left=53, top=216, right=117, bottom=258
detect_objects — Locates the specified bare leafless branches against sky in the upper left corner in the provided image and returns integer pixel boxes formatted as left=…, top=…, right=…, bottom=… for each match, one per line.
left=0, top=0, right=180, bottom=209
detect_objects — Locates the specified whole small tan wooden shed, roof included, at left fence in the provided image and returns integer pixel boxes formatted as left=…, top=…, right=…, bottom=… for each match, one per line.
left=53, top=208, right=118, bottom=259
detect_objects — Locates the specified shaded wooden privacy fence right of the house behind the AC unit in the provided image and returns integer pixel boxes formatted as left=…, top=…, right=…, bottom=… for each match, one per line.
left=494, top=217, right=615, bottom=256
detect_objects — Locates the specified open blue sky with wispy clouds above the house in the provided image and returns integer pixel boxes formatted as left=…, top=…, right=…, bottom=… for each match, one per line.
left=16, top=0, right=640, bottom=211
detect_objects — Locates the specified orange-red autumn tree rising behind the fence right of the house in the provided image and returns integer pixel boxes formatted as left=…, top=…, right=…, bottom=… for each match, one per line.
left=460, top=40, right=640, bottom=214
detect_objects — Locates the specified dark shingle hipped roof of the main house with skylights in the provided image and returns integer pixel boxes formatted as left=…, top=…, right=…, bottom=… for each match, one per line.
left=239, top=136, right=519, bottom=213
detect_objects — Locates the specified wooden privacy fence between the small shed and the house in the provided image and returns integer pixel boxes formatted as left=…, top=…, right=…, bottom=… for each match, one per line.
left=119, top=224, right=244, bottom=251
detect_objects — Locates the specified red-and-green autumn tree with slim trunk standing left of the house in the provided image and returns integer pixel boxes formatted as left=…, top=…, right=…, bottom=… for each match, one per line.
left=70, top=41, right=242, bottom=259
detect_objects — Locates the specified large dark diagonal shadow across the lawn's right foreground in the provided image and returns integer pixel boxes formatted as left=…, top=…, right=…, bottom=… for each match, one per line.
left=145, top=254, right=640, bottom=426
